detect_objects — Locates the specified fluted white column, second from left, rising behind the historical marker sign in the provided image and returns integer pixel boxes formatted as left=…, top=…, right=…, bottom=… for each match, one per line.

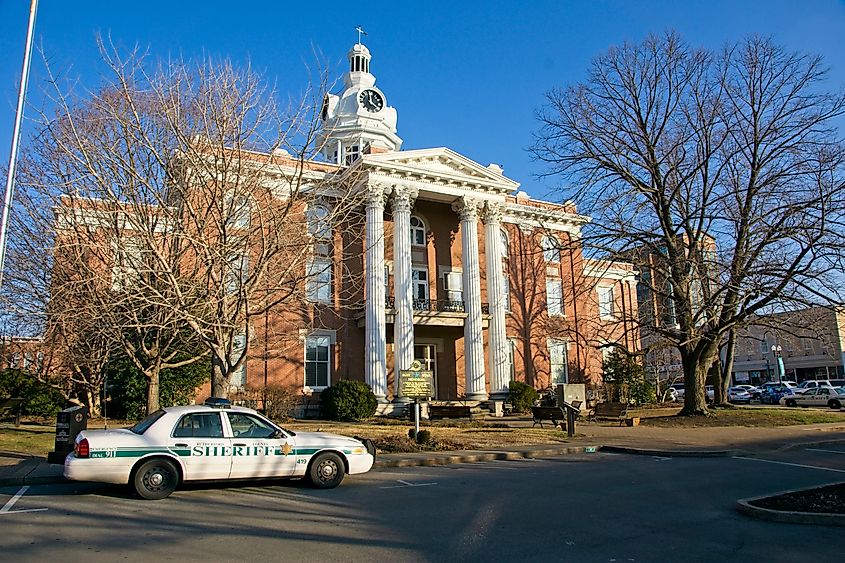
left=392, top=188, right=417, bottom=400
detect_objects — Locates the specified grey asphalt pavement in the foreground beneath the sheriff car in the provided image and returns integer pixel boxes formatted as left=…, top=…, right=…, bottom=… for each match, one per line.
left=0, top=441, right=845, bottom=561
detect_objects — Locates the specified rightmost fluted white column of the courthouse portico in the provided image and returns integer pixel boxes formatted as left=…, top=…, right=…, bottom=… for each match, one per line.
left=483, top=203, right=510, bottom=400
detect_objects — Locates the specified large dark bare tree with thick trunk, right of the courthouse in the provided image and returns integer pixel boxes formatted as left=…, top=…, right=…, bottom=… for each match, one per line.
left=533, top=33, right=845, bottom=414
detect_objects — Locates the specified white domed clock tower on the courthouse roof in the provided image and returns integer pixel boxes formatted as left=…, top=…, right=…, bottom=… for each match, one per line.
left=319, top=41, right=402, bottom=165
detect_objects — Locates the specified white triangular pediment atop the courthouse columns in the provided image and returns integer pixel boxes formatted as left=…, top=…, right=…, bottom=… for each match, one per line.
left=363, top=148, right=519, bottom=193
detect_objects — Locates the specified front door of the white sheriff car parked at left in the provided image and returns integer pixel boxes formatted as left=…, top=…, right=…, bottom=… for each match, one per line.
left=226, top=412, right=296, bottom=479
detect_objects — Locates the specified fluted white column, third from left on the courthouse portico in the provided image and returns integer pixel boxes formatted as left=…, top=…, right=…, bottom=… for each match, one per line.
left=453, top=198, right=487, bottom=401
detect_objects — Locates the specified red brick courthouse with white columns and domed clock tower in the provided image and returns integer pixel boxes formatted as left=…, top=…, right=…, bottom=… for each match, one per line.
left=227, top=43, right=639, bottom=410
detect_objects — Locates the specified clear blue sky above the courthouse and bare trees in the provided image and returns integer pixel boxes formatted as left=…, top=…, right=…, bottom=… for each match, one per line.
left=0, top=0, right=845, bottom=197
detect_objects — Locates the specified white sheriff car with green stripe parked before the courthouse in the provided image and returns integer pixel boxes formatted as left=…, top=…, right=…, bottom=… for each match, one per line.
left=64, top=399, right=375, bottom=500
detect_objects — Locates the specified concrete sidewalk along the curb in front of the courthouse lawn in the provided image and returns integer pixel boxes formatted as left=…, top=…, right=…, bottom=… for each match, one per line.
left=0, top=419, right=845, bottom=487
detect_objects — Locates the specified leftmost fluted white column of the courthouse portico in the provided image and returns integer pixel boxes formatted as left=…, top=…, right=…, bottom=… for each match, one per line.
left=364, top=187, right=387, bottom=402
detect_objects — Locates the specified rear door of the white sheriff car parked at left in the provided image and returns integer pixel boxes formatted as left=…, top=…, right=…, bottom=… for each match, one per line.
left=171, top=411, right=232, bottom=480
